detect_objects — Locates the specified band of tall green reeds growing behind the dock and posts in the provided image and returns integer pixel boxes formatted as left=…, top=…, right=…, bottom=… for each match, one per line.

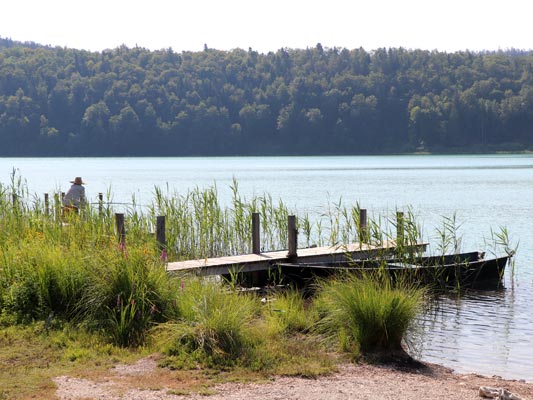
left=0, top=173, right=420, bottom=260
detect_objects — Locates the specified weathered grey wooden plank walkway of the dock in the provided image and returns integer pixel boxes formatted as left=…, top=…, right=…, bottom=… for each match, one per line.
left=167, top=241, right=427, bottom=276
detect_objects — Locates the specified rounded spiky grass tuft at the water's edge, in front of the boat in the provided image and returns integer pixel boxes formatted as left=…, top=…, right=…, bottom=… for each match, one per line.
left=316, top=274, right=425, bottom=354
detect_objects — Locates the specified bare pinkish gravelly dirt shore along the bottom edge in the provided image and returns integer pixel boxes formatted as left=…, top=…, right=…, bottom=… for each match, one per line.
left=55, top=357, right=533, bottom=400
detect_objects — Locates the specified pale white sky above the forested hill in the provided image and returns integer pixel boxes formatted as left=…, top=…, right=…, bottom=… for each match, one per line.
left=0, top=0, right=533, bottom=53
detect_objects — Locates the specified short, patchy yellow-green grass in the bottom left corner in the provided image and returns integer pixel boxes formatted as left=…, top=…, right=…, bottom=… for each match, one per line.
left=0, top=322, right=136, bottom=399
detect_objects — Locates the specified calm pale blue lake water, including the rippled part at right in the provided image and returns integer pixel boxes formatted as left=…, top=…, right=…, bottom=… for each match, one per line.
left=0, top=155, right=533, bottom=381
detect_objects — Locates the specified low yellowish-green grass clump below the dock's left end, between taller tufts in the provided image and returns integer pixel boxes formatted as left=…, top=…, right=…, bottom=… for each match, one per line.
left=158, top=280, right=260, bottom=368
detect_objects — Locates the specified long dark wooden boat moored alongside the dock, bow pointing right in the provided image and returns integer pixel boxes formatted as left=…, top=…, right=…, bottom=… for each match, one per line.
left=278, top=251, right=512, bottom=289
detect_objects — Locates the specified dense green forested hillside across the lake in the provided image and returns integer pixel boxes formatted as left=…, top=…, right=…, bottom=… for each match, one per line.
left=0, top=38, right=533, bottom=156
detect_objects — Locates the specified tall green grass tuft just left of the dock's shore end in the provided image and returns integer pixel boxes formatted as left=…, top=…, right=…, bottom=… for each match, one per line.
left=74, top=248, right=170, bottom=347
